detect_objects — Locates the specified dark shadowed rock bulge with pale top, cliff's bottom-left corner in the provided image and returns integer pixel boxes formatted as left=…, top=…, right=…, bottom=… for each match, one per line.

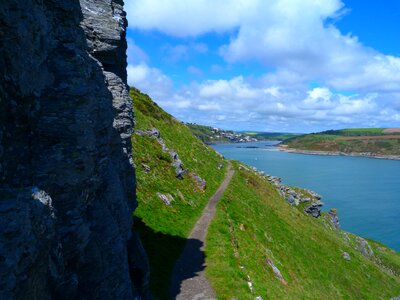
left=0, top=188, right=63, bottom=299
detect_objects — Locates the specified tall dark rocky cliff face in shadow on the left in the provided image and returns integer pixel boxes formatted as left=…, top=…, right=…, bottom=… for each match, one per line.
left=0, top=0, right=148, bottom=299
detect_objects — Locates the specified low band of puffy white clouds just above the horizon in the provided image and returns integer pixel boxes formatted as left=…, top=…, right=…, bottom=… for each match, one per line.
left=136, top=76, right=399, bottom=132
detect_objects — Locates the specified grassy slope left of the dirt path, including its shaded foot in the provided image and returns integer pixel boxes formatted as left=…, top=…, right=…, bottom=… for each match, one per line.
left=130, top=89, right=226, bottom=299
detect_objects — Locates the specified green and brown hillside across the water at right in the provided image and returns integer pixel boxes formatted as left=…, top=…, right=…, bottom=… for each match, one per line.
left=282, top=128, right=400, bottom=156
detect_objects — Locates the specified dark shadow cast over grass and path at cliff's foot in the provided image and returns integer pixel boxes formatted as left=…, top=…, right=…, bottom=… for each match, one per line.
left=134, top=217, right=205, bottom=299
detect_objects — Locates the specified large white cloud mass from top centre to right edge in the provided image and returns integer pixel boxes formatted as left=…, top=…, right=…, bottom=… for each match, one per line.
left=126, top=0, right=400, bottom=92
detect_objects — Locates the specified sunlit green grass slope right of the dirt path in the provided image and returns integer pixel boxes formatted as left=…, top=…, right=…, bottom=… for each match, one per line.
left=206, top=164, right=400, bottom=299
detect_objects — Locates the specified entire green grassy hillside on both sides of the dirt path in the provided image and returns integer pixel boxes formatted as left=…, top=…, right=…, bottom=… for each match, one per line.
left=131, top=89, right=400, bottom=299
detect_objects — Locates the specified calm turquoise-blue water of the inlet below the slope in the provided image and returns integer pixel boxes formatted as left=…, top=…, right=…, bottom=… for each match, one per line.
left=213, top=142, right=400, bottom=251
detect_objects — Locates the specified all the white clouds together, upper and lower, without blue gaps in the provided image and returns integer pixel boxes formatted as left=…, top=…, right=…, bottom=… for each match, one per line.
left=126, top=0, right=400, bottom=131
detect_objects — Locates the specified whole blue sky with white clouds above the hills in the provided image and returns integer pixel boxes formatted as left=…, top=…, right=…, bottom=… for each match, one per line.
left=125, top=0, right=400, bottom=133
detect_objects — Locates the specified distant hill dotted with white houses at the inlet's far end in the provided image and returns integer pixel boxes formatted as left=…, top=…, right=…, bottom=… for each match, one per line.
left=186, top=123, right=297, bottom=144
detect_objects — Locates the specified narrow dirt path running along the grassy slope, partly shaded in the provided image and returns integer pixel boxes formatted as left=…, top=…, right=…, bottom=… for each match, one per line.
left=170, top=163, right=234, bottom=300
